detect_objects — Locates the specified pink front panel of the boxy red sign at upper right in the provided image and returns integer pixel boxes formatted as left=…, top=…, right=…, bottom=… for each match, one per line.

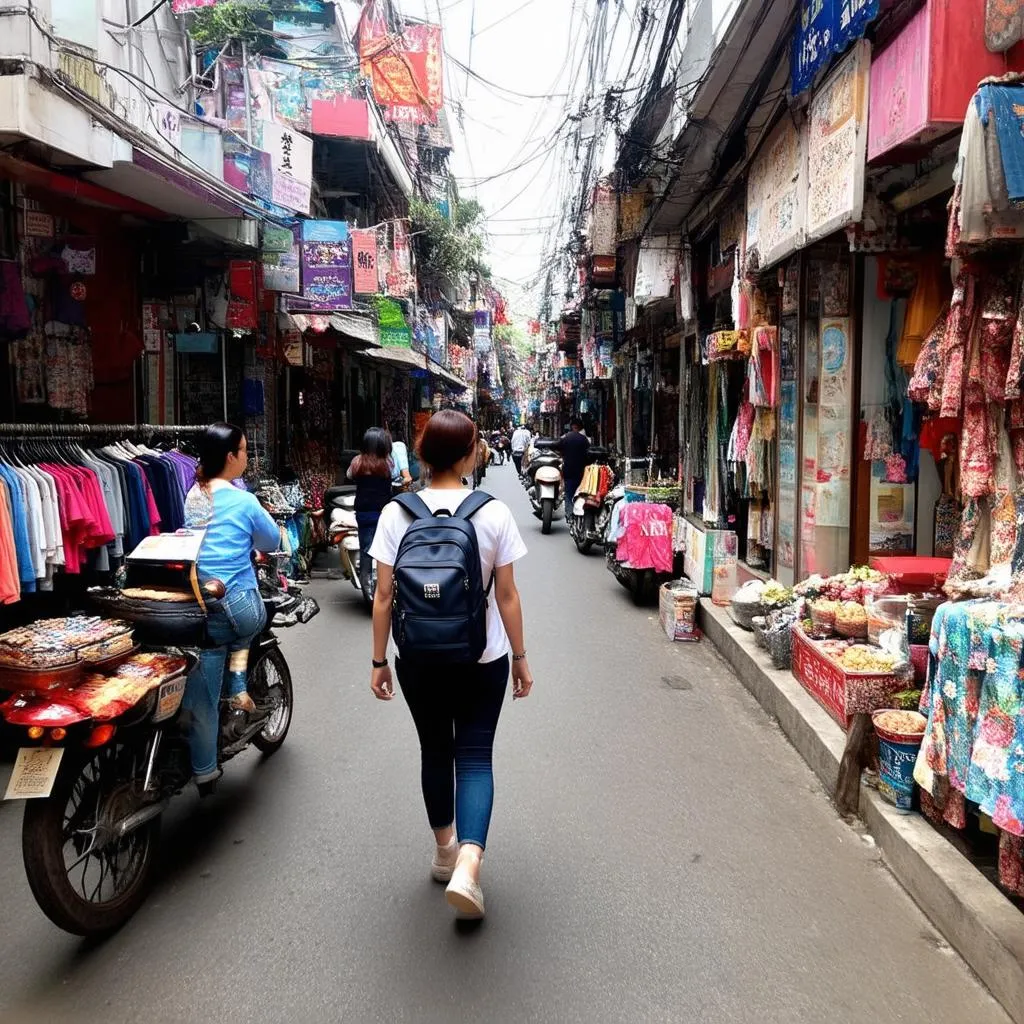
left=867, top=4, right=931, bottom=160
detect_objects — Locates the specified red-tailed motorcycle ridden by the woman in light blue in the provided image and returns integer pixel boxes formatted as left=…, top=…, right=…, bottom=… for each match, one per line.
left=0, top=560, right=318, bottom=935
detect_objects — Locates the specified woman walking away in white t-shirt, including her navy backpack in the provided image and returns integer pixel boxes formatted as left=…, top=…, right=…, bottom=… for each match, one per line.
left=370, top=410, right=534, bottom=918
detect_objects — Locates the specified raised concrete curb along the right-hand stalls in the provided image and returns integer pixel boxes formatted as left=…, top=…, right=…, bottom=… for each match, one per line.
left=699, top=598, right=1024, bottom=1024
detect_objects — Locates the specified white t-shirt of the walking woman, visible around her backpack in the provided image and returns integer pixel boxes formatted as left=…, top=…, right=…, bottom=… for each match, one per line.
left=370, top=487, right=526, bottom=664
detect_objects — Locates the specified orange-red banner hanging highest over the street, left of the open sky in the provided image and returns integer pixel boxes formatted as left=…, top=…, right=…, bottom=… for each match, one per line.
left=358, top=11, right=444, bottom=124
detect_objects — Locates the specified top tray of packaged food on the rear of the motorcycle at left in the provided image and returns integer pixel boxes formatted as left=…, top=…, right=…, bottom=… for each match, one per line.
left=0, top=615, right=134, bottom=672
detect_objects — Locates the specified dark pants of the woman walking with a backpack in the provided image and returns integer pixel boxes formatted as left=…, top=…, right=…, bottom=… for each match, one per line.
left=395, top=655, right=509, bottom=849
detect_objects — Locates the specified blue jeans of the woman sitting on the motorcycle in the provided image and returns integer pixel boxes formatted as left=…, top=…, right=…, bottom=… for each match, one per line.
left=181, top=587, right=266, bottom=781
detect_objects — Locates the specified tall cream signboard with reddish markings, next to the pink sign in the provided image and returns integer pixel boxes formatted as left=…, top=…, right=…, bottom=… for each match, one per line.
left=807, top=40, right=871, bottom=242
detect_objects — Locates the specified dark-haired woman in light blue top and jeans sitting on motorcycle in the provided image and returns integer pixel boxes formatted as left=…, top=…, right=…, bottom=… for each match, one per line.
left=183, top=423, right=281, bottom=794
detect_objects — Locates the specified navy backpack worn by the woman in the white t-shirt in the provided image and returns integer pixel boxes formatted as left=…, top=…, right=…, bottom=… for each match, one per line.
left=391, top=490, right=494, bottom=664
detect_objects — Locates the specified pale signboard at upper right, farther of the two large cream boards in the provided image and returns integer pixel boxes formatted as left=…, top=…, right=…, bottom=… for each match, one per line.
left=746, top=117, right=807, bottom=269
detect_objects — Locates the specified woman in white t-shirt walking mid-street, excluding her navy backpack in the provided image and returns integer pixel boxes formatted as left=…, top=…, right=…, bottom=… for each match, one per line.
left=370, top=410, right=534, bottom=918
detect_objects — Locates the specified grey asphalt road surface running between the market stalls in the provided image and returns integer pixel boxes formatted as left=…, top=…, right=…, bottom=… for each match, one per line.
left=0, top=466, right=1008, bottom=1024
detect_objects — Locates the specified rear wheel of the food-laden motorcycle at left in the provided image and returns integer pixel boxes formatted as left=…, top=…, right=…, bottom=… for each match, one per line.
left=22, top=742, right=160, bottom=935
